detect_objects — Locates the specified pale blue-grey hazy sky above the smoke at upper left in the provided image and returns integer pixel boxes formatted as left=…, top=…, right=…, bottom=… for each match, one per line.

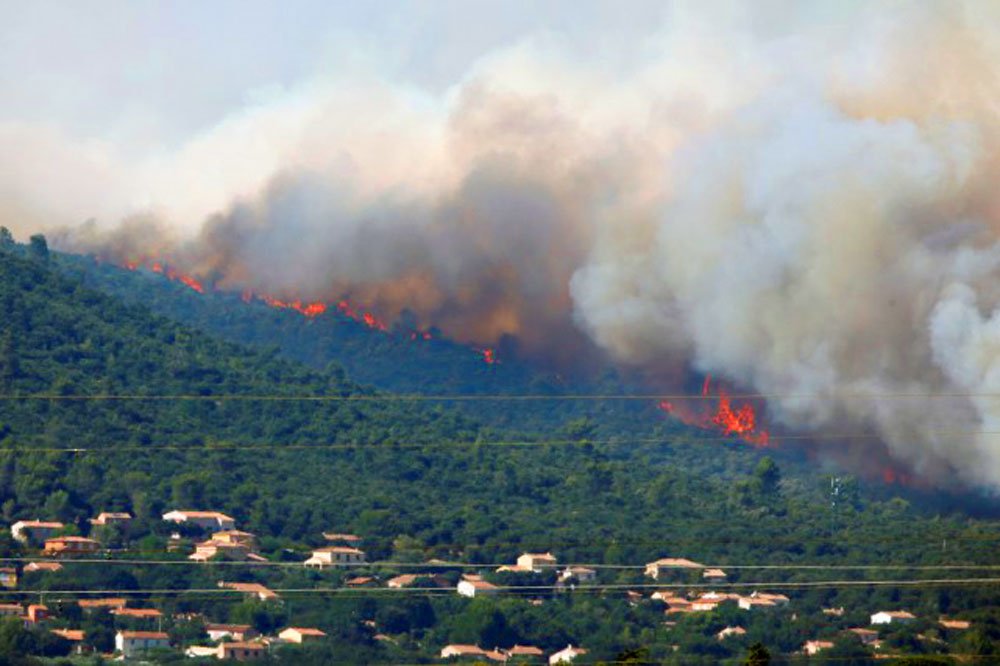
left=0, top=0, right=680, bottom=148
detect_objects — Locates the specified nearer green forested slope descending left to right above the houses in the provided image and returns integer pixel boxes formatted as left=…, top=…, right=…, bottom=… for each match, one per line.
left=0, top=233, right=1000, bottom=663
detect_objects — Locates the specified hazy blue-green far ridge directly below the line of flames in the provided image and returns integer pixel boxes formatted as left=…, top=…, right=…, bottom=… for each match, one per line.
left=54, top=249, right=656, bottom=431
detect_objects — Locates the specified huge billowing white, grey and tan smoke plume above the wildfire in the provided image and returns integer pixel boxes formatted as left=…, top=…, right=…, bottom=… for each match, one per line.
left=9, top=2, right=1000, bottom=487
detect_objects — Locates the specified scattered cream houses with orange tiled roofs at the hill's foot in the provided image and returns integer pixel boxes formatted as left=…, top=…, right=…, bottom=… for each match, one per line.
left=0, top=510, right=969, bottom=664
